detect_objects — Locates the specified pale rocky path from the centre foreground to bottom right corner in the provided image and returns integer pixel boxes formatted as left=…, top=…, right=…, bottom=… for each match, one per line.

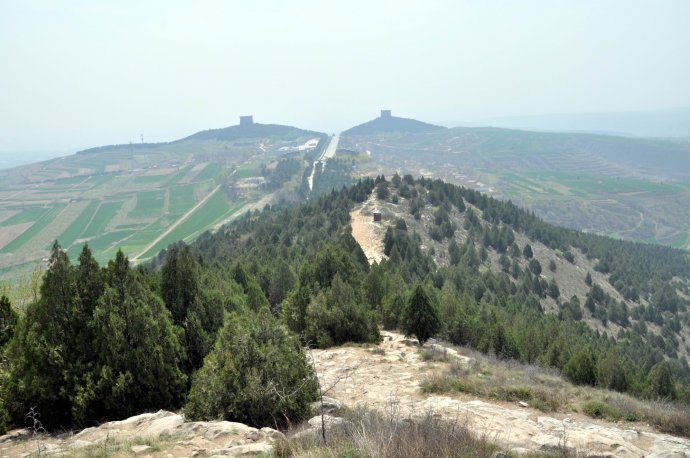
left=313, top=331, right=690, bottom=457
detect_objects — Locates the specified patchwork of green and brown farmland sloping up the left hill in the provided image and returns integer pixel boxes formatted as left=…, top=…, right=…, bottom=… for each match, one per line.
left=0, top=124, right=321, bottom=286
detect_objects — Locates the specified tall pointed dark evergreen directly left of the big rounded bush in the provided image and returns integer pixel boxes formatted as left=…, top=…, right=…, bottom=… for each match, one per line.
left=90, top=252, right=186, bottom=418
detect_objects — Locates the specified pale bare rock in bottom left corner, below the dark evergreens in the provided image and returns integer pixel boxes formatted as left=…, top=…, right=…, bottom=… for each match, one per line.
left=0, top=410, right=284, bottom=458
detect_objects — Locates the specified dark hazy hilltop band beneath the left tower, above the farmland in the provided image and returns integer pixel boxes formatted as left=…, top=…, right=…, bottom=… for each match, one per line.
left=77, top=122, right=324, bottom=154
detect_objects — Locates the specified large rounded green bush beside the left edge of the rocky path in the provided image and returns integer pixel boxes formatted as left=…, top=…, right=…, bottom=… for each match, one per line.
left=184, top=310, right=317, bottom=427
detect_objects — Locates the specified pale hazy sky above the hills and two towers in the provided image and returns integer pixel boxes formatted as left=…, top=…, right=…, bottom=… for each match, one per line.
left=0, top=0, right=690, bottom=156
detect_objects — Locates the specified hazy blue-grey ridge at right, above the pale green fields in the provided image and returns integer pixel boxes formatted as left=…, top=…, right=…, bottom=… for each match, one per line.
left=341, top=125, right=690, bottom=181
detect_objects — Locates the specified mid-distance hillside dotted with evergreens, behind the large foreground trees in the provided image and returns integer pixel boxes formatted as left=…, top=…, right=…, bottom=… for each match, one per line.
left=189, top=176, right=690, bottom=397
